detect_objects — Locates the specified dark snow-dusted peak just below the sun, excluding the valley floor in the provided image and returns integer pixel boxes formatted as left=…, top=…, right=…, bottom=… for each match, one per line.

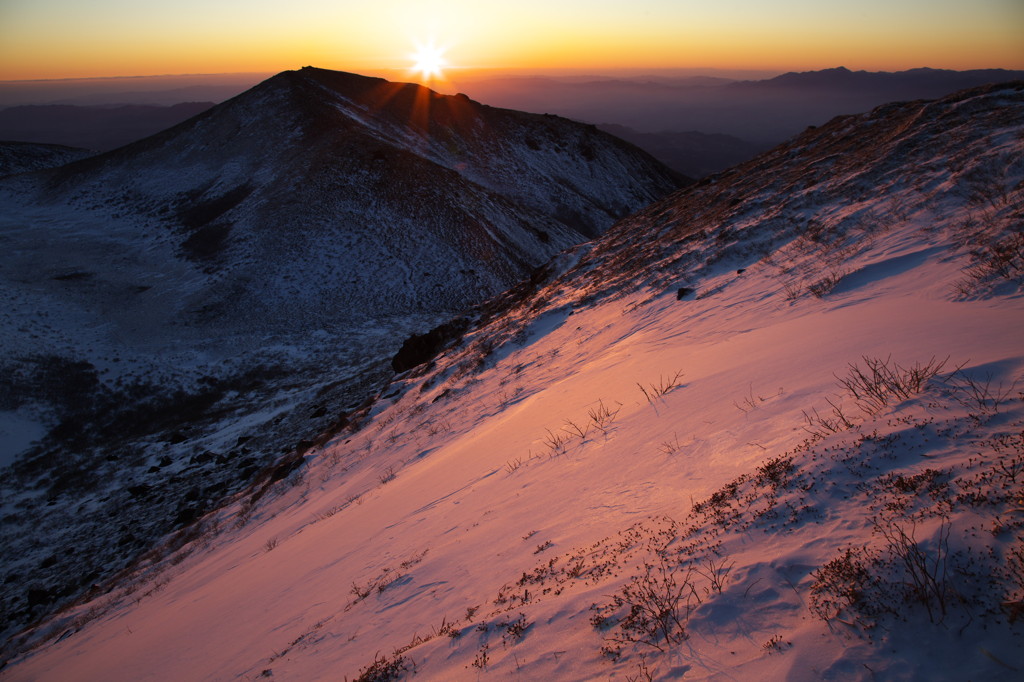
left=10, top=68, right=675, bottom=332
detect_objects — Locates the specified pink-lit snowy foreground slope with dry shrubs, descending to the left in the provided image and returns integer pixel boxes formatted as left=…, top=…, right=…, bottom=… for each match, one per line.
left=0, top=83, right=1024, bottom=680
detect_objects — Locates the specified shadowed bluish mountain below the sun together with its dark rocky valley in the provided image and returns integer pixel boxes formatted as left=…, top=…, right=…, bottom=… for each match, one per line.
left=0, top=68, right=677, bottom=643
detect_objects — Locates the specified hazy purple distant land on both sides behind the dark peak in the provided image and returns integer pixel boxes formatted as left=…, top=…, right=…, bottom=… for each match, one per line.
left=8, top=68, right=1024, bottom=178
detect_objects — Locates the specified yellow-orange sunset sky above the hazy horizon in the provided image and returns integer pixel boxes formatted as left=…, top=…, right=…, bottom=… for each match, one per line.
left=0, top=0, right=1024, bottom=80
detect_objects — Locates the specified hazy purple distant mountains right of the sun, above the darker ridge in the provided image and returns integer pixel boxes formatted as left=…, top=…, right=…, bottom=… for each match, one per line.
left=466, top=68, right=1024, bottom=144
